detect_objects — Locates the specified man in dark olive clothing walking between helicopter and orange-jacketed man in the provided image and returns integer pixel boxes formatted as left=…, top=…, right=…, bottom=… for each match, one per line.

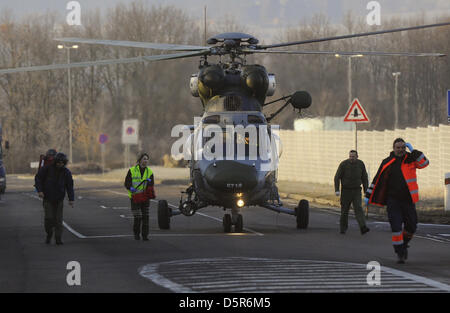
left=334, top=150, right=370, bottom=235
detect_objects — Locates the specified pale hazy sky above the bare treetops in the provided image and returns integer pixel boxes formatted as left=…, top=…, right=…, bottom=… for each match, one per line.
left=0, top=0, right=450, bottom=37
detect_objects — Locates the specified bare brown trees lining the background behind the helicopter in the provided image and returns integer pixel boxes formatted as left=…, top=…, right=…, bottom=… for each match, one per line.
left=0, top=2, right=450, bottom=172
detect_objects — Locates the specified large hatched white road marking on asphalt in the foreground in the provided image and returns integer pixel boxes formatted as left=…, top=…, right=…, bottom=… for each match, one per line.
left=138, top=257, right=450, bottom=293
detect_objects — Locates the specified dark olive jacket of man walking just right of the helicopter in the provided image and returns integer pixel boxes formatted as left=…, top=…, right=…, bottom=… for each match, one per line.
left=334, top=159, right=369, bottom=192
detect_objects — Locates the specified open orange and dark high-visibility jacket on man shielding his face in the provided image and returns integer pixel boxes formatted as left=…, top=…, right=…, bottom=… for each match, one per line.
left=365, top=150, right=430, bottom=206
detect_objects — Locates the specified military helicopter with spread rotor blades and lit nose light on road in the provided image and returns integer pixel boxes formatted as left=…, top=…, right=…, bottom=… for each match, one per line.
left=0, top=22, right=450, bottom=232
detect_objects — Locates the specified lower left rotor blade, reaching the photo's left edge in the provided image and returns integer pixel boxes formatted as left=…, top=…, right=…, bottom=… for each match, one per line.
left=0, top=50, right=209, bottom=75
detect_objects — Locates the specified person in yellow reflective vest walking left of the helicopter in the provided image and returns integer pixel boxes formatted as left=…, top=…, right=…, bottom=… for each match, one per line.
left=125, top=153, right=154, bottom=241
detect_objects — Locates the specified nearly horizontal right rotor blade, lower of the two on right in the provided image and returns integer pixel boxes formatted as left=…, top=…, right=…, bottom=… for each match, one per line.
left=242, top=49, right=446, bottom=57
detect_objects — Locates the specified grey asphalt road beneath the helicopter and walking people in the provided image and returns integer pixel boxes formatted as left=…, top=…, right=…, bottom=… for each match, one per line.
left=0, top=176, right=450, bottom=293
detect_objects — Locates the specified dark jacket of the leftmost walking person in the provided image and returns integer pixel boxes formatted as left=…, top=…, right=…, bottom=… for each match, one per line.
left=34, top=164, right=75, bottom=202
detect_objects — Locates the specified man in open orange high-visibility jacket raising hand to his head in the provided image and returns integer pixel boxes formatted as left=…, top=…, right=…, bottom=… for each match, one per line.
left=364, top=138, right=430, bottom=264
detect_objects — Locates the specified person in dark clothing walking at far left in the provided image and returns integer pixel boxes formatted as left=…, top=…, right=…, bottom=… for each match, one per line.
left=34, top=153, right=75, bottom=245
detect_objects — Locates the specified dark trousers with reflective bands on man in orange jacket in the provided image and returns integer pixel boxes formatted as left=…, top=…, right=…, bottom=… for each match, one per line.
left=387, top=198, right=417, bottom=253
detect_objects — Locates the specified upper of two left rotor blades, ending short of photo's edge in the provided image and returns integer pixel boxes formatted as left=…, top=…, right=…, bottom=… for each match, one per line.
left=54, top=38, right=209, bottom=51
